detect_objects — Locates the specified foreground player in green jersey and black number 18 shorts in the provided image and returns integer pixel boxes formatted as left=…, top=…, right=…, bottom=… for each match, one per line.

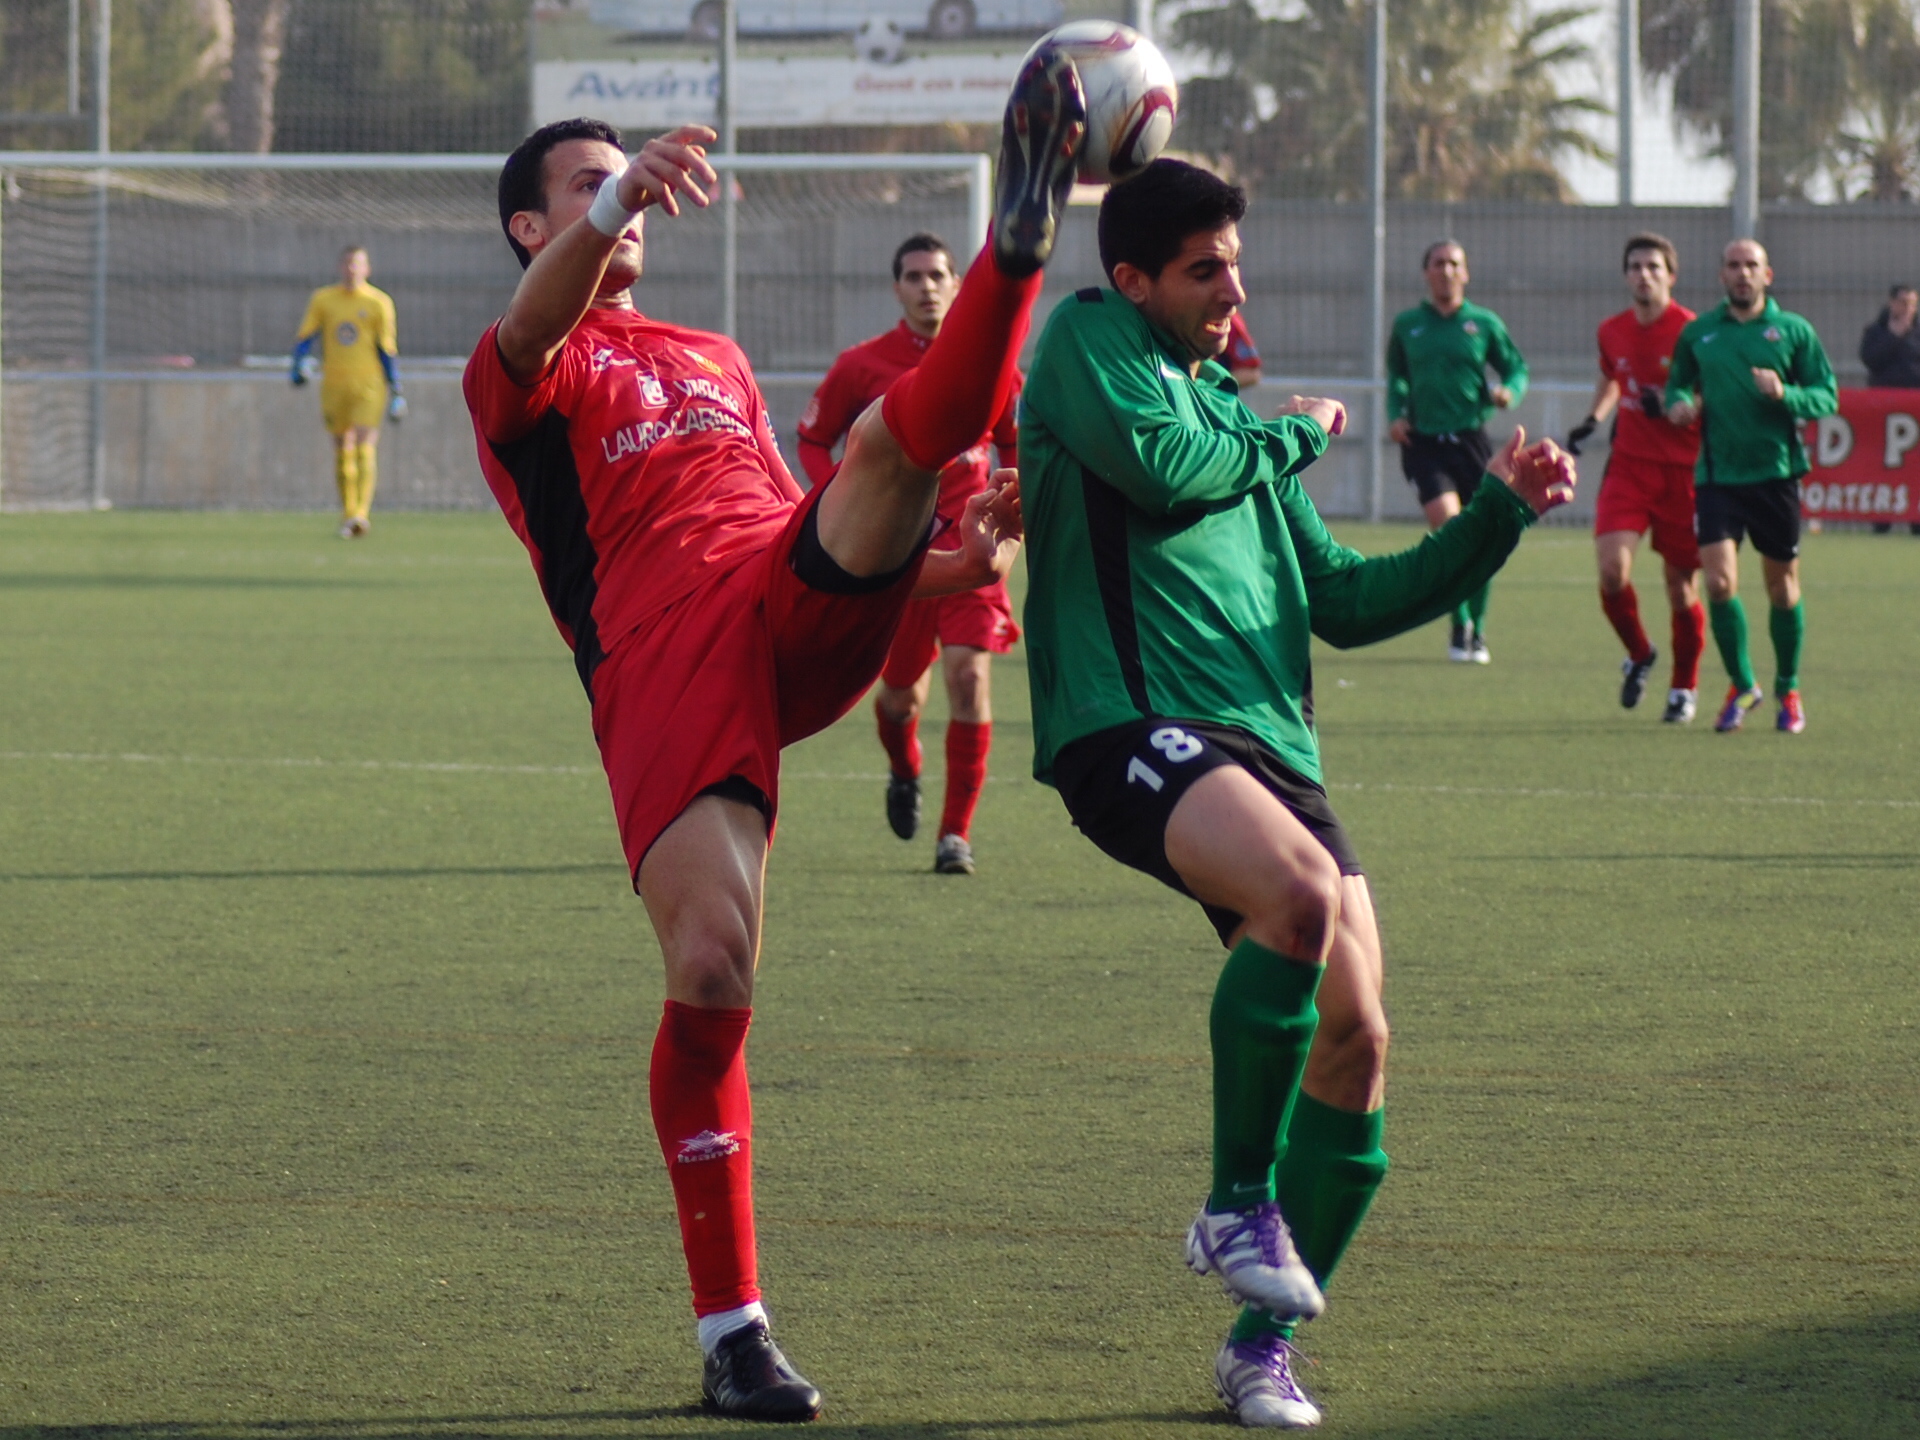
left=1020, top=159, right=1572, bottom=1427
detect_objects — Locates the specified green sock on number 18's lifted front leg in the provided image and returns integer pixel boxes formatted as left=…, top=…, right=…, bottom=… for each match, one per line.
left=1208, top=941, right=1323, bottom=1210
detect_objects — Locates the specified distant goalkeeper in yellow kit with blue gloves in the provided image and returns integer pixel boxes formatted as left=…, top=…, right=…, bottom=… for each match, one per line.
left=294, top=246, right=407, bottom=540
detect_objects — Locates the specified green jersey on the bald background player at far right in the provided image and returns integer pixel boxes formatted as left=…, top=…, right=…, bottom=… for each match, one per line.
left=1667, top=296, right=1839, bottom=486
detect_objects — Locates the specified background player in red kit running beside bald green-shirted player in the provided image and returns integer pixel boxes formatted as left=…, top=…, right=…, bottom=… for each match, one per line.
left=1569, top=234, right=1707, bottom=726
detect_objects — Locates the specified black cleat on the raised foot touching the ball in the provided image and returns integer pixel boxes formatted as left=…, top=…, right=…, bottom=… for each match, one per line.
left=993, top=42, right=1087, bottom=280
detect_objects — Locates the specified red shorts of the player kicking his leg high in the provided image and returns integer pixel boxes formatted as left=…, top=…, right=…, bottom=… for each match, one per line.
left=593, top=486, right=920, bottom=889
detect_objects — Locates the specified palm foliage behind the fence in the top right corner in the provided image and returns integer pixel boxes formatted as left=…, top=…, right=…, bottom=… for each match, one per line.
left=1640, top=0, right=1920, bottom=200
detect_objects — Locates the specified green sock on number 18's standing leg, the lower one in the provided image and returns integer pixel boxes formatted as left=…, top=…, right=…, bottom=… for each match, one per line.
left=1233, top=1094, right=1388, bottom=1340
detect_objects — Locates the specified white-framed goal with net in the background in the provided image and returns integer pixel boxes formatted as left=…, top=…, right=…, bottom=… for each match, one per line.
left=0, top=150, right=991, bottom=509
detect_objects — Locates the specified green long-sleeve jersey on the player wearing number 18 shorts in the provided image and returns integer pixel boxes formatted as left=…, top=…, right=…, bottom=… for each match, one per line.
left=1020, top=290, right=1532, bottom=781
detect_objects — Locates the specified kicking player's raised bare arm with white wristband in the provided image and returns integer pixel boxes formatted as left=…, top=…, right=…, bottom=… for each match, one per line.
left=495, top=125, right=718, bottom=380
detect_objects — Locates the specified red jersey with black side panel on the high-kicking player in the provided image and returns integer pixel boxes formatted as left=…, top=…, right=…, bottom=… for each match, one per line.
left=463, top=307, right=801, bottom=695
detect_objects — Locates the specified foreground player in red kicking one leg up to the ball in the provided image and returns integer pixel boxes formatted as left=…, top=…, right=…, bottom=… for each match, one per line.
left=465, top=46, right=1087, bottom=1421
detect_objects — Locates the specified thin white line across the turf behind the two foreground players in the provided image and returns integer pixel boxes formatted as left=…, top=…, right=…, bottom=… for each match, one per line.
left=0, top=751, right=1920, bottom=810
